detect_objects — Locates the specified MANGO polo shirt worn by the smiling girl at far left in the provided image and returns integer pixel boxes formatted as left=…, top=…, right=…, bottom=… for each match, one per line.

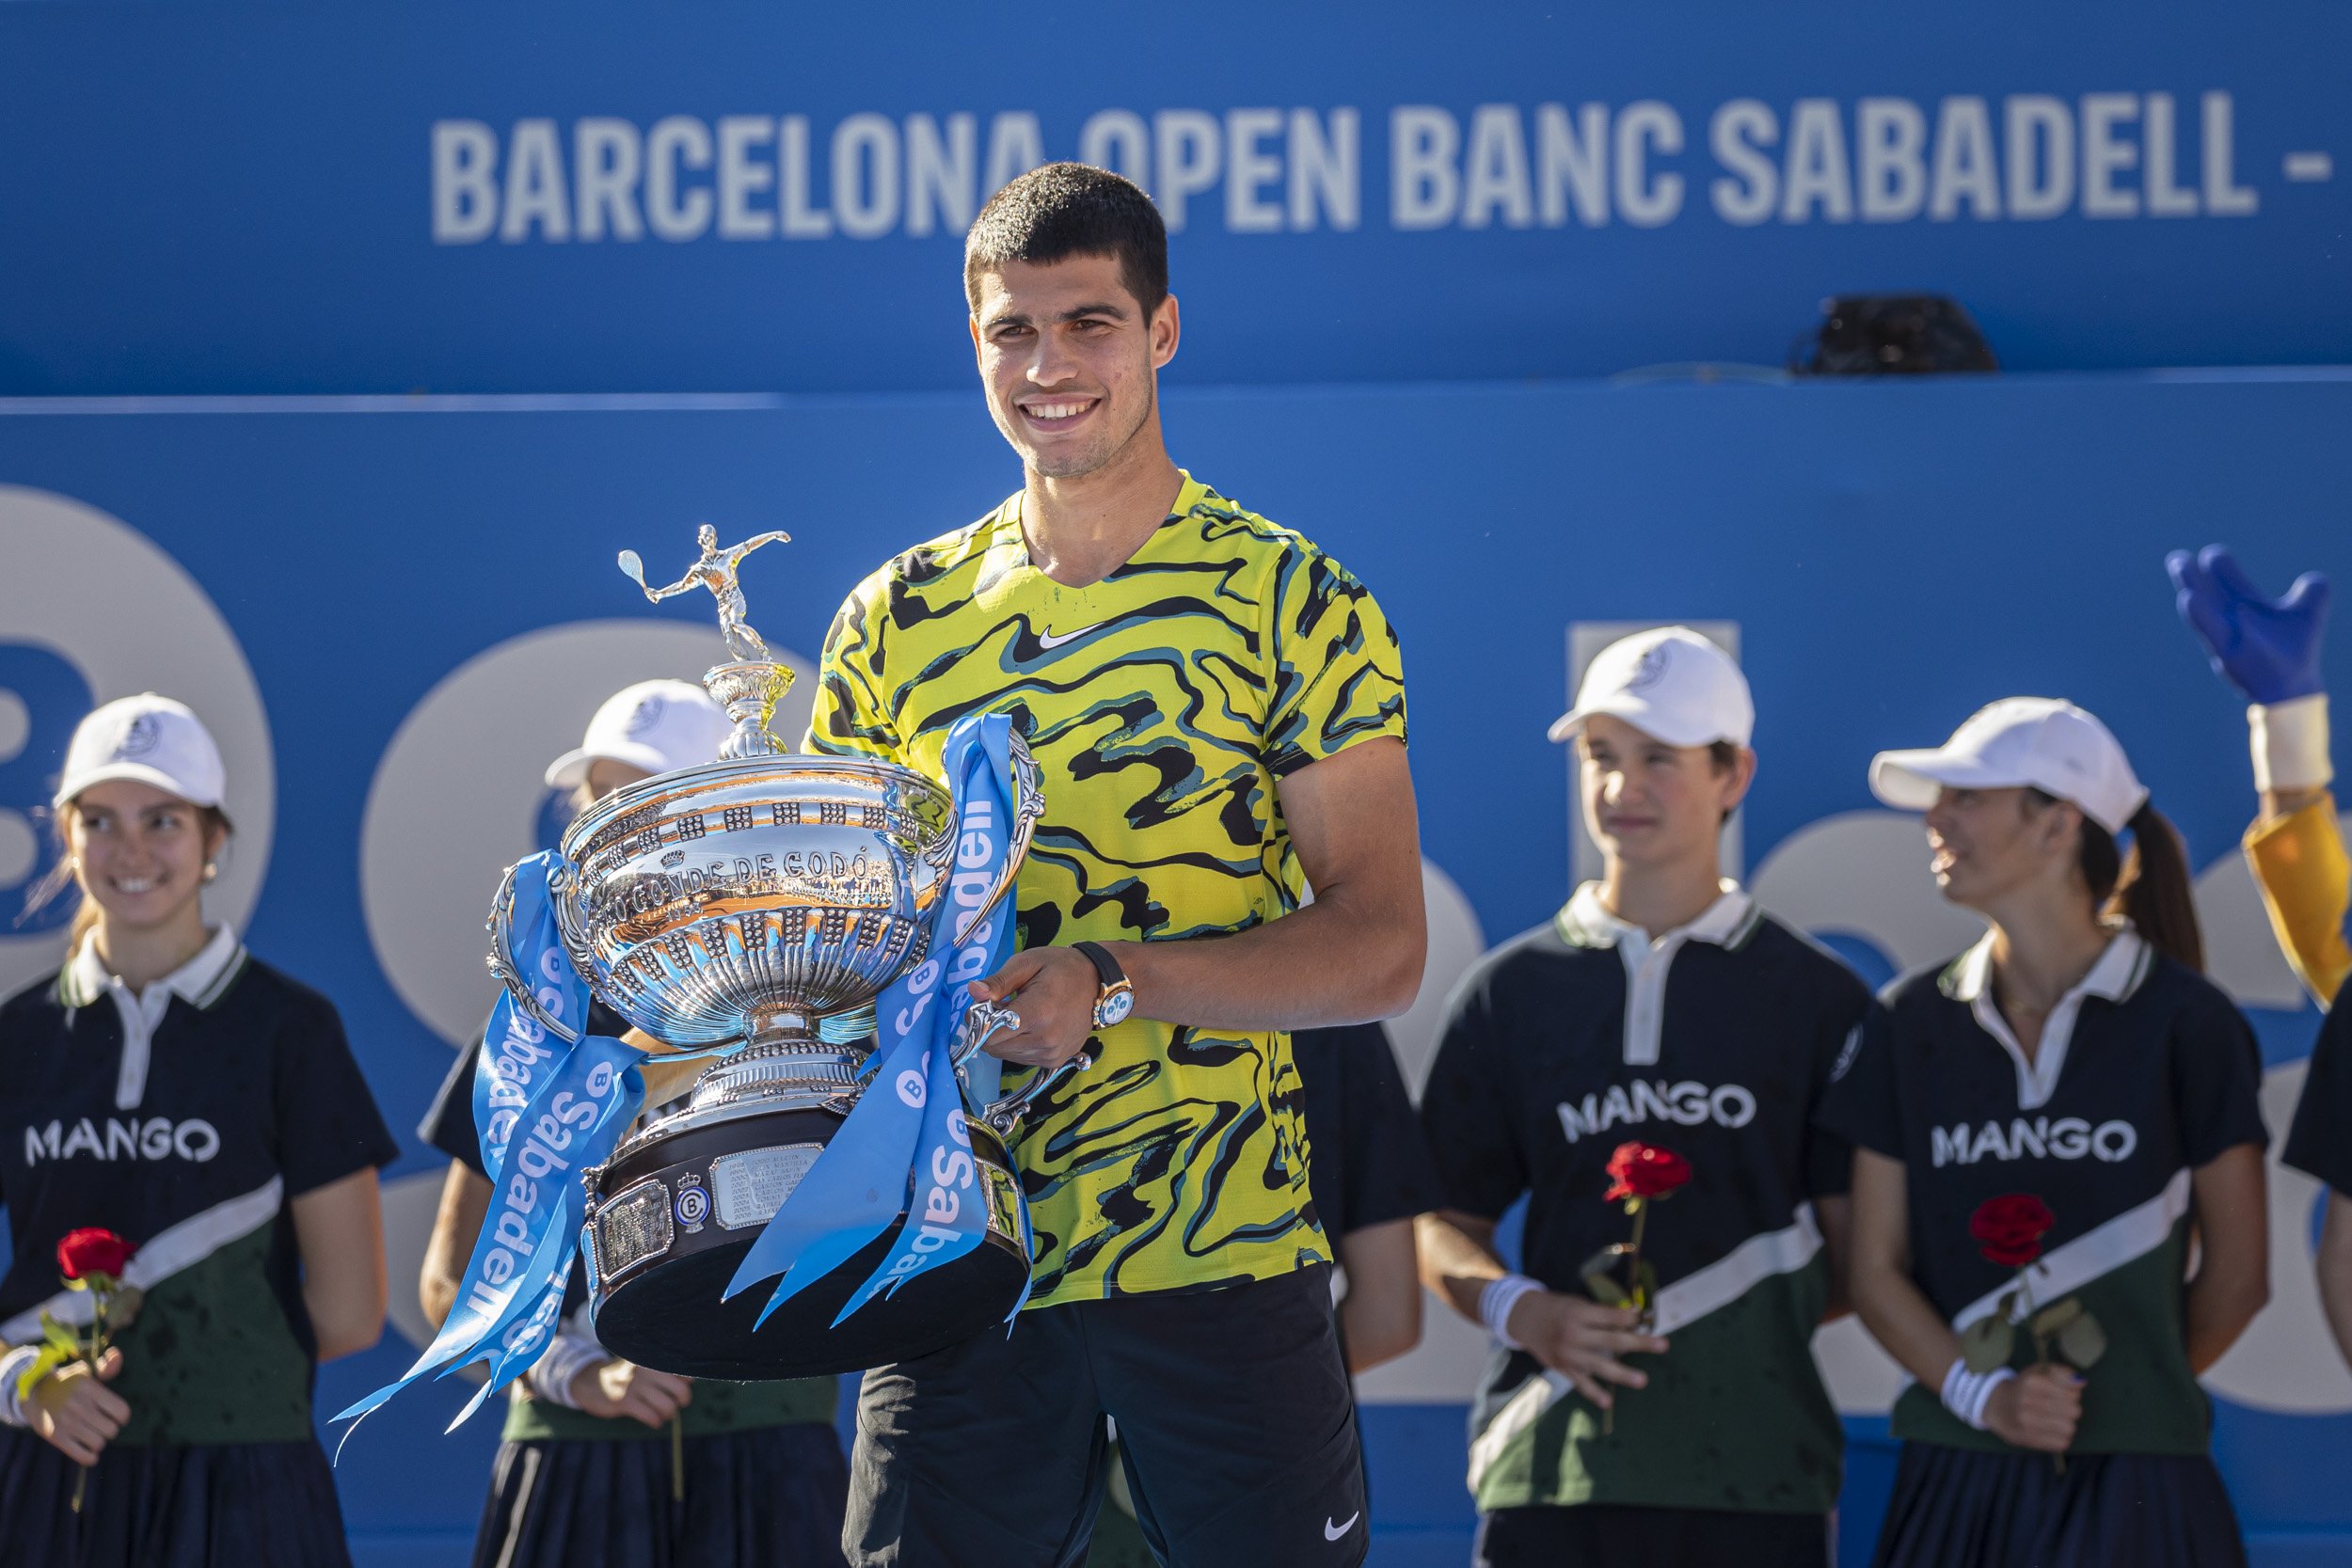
left=0, top=931, right=400, bottom=1444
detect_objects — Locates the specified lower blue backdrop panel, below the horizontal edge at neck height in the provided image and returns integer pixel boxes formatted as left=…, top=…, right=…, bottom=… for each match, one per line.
left=0, top=376, right=2352, bottom=1568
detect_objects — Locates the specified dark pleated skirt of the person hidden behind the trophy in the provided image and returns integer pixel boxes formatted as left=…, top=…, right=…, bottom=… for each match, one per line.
left=473, top=1422, right=850, bottom=1568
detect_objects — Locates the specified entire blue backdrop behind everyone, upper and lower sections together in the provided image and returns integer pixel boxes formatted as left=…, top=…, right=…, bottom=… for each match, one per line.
left=0, top=0, right=2352, bottom=1568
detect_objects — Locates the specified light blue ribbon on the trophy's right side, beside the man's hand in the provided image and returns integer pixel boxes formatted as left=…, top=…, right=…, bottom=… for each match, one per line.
left=724, top=715, right=1028, bottom=1323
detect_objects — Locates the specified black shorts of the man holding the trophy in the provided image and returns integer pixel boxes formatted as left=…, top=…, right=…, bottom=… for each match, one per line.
left=842, top=1267, right=1372, bottom=1568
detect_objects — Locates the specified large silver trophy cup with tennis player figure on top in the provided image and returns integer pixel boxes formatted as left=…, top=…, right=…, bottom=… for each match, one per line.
left=489, top=524, right=1063, bottom=1378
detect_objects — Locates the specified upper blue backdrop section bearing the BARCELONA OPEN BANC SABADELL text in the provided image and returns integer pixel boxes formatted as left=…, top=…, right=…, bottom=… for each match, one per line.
left=0, top=0, right=2352, bottom=392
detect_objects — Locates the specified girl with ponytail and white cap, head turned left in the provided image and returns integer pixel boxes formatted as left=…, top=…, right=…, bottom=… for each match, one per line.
left=1823, top=698, right=2267, bottom=1568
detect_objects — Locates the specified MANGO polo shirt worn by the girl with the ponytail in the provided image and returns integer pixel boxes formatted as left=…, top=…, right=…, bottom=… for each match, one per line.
left=1823, top=928, right=2265, bottom=1455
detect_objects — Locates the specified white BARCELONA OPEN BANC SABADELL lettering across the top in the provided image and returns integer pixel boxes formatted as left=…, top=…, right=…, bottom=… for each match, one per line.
left=431, top=89, right=2261, bottom=245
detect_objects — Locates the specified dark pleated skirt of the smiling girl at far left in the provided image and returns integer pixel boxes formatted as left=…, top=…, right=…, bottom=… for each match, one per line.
left=0, top=1427, right=351, bottom=1568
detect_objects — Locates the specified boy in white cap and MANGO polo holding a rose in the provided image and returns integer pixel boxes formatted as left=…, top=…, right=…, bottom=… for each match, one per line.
left=1421, top=627, right=1870, bottom=1568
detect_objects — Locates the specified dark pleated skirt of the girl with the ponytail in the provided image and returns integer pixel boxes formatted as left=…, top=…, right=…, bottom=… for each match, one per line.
left=1872, top=1444, right=2247, bottom=1568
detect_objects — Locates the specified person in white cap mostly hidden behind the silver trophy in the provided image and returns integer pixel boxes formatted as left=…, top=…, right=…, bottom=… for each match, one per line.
left=417, top=679, right=850, bottom=1568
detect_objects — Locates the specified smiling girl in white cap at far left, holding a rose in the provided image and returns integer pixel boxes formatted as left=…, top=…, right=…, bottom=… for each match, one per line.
left=0, top=696, right=395, bottom=1568
